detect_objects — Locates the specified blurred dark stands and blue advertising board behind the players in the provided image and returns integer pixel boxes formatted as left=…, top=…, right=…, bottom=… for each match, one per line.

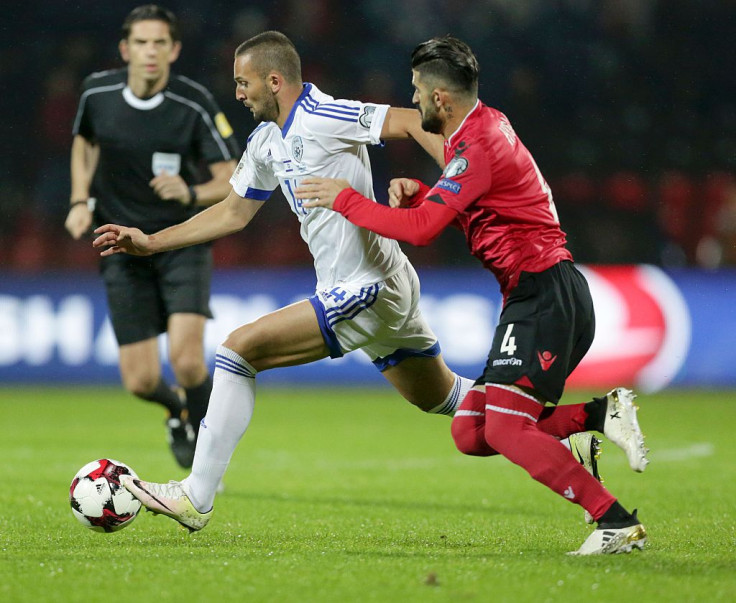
left=0, top=0, right=736, bottom=389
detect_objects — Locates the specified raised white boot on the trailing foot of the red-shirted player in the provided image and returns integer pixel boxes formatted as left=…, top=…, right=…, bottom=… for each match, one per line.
left=603, top=387, right=649, bottom=473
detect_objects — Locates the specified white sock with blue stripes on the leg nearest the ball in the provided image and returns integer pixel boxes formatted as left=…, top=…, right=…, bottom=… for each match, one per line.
left=182, top=346, right=256, bottom=513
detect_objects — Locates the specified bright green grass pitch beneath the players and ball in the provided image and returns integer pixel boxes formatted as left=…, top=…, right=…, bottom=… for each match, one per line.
left=0, top=386, right=736, bottom=603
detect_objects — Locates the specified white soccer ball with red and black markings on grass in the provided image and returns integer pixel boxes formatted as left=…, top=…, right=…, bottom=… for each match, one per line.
left=69, top=459, right=141, bottom=532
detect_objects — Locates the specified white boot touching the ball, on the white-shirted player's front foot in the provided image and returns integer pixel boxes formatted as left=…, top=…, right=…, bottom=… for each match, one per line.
left=120, top=475, right=212, bottom=532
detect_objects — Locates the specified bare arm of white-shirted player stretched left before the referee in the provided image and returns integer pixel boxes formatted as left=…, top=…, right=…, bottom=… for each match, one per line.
left=92, top=190, right=263, bottom=256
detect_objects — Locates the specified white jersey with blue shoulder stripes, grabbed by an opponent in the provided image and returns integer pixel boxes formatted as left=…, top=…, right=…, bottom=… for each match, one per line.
left=230, top=84, right=406, bottom=290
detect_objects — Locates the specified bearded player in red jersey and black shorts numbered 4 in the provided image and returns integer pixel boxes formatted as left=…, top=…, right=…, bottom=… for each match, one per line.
left=297, top=36, right=648, bottom=555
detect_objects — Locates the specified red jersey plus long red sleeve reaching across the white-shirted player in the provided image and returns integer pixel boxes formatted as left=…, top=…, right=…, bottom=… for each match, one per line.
left=333, top=101, right=572, bottom=297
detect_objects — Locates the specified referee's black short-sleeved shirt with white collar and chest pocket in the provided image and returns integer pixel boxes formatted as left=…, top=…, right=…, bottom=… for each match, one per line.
left=73, top=69, right=240, bottom=232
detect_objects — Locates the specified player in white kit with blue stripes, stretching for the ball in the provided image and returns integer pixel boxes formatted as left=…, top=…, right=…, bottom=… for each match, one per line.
left=94, top=32, right=594, bottom=531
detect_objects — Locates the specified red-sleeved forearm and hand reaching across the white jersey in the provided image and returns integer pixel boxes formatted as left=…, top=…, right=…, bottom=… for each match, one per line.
left=295, top=178, right=457, bottom=245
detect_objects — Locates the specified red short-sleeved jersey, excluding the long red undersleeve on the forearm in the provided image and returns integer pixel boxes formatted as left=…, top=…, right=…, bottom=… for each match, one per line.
left=432, top=101, right=572, bottom=295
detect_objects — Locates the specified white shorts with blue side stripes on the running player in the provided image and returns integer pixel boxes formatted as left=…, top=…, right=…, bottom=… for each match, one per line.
left=309, top=262, right=440, bottom=371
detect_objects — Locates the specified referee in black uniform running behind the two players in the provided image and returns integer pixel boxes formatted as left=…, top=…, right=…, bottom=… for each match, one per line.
left=65, top=5, right=240, bottom=467
